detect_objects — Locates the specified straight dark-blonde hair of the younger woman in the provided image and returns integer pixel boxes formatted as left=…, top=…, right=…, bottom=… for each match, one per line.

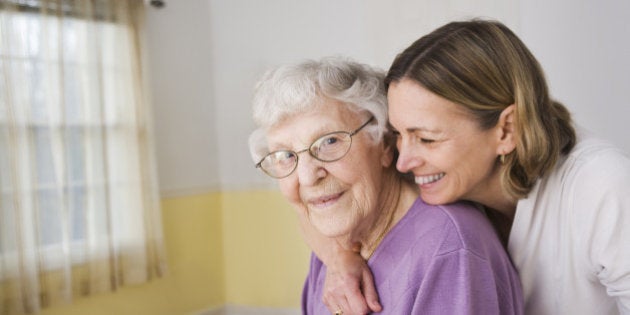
left=385, top=20, right=576, bottom=198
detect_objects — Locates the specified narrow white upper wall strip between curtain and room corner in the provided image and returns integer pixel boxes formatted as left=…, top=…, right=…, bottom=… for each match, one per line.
left=146, top=0, right=220, bottom=196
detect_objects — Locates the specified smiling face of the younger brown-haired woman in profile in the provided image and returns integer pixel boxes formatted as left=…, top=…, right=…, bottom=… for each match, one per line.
left=387, top=79, right=498, bottom=204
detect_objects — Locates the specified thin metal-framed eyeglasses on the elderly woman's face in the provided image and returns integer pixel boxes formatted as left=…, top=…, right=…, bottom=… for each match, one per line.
left=256, top=116, right=374, bottom=178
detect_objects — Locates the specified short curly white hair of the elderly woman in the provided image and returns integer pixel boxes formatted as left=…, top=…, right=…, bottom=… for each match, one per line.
left=249, top=57, right=387, bottom=162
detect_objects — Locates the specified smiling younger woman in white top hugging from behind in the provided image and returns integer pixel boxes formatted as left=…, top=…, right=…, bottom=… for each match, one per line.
left=320, top=20, right=630, bottom=315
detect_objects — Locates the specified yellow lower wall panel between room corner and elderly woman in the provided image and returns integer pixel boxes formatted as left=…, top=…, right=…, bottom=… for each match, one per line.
left=223, top=191, right=309, bottom=307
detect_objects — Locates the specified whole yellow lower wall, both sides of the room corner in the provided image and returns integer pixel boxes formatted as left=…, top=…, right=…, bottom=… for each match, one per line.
left=37, top=191, right=308, bottom=315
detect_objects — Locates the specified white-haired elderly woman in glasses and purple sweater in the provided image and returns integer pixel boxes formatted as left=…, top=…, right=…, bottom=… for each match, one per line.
left=250, top=58, right=522, bottom=315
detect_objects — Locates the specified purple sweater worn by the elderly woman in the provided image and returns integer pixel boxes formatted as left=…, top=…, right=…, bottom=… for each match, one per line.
left=302, top=198, right=523, bottom=315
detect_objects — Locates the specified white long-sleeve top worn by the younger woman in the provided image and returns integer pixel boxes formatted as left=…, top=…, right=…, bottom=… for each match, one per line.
left=508, top=131, right=630, bottom=315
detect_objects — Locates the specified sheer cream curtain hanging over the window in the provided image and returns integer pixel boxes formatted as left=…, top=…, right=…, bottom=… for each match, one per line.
left=0, top=0, right=165, bottom=314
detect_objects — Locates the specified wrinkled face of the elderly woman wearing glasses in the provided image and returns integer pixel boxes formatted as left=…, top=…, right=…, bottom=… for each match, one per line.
left=267, top=101, right=392, bottom=237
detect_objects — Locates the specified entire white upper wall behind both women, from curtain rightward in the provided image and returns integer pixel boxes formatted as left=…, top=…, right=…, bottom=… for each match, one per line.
left=148, top=0, right=630, bottom=191
